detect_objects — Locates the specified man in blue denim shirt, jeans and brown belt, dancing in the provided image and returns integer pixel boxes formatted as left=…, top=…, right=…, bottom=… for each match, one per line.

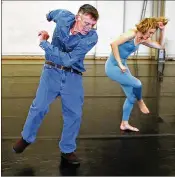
left=13, top=4, right=99, bottom=164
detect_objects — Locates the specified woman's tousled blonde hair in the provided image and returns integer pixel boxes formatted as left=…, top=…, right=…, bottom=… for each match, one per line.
left=136, top=17, right=168, bottom=34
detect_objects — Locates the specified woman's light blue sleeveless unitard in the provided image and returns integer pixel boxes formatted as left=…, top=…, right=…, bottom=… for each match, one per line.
left=105, top=39, right=142, bottom=121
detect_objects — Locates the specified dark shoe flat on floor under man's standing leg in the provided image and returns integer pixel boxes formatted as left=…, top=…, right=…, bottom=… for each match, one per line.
left=61, top=152, right=80, bottom=165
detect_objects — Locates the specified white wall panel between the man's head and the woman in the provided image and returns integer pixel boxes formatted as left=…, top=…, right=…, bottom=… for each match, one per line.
left=96, top=1, right=124, bottom=56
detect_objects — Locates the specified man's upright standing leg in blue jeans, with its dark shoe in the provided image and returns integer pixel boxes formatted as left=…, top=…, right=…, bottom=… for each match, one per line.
left=59, top=73, right=84, bottom=164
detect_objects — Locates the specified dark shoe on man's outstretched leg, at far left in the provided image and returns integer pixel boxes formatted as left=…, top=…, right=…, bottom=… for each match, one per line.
left=13, top=138, right=30, bottom=153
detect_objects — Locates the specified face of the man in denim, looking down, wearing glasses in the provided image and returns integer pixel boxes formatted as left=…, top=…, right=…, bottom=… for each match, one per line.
left=76, top=14, right=97, bottom=35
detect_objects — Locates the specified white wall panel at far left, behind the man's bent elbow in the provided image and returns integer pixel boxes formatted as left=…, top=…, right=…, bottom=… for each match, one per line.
left=2, top=1, right=96, bottom=55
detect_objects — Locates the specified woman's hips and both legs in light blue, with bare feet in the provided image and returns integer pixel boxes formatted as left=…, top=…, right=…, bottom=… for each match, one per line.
left=105, top=61, right=149, bottom=131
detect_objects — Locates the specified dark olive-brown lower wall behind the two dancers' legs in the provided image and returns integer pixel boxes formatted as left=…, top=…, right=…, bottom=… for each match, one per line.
left=2, top=60, right=175, bottom=137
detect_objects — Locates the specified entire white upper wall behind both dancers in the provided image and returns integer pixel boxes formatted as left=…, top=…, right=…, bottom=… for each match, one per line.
left=2, top=0, right=175, bottom=57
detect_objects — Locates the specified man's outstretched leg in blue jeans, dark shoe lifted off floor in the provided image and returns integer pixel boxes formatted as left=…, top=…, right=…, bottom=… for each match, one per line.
left=13, top=69, right=59, bottom=153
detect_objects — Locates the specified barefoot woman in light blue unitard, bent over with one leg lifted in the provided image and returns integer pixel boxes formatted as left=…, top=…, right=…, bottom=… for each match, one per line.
left=105, top=17, right=168, bottom=131
